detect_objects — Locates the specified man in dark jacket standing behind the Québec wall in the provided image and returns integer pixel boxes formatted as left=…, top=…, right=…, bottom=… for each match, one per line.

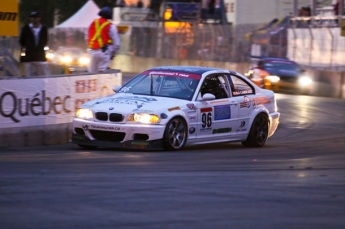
left=19, top=11, right=49, bottom=77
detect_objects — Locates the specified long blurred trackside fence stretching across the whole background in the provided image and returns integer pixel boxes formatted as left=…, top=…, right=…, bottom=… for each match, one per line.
left=0, top=21, right=345, bottom=74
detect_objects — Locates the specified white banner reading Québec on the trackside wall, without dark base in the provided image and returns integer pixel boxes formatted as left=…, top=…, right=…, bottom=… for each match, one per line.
left=0, top=74, right=121, bottom=129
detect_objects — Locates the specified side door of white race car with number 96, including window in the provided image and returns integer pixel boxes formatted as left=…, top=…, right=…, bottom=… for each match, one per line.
left=196, top=74, right=239, bottom=141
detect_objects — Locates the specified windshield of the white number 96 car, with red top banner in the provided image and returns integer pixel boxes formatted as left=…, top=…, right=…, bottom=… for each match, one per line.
left=117, top=70, right=201, bottom=100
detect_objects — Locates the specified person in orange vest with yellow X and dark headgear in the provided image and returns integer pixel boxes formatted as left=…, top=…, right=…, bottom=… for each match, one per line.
left=87, top=7, right=120, bottom=72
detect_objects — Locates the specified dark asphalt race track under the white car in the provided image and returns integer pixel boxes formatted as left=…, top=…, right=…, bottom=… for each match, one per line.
left=0, top=81, right=345, bottom=229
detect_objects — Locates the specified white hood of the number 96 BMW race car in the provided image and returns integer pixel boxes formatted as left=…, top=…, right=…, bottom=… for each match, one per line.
left=81, top=93, right=189, bottom=114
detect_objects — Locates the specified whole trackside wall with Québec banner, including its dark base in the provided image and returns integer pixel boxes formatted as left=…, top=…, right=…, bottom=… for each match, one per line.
left=0, top=70, right=122, bottom=147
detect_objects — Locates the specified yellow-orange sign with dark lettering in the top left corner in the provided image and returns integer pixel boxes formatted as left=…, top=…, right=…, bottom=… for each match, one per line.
left=0, top=0, right=19, bottom=36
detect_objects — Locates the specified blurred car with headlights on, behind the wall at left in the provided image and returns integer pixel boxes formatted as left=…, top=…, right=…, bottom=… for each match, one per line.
left=50, top=47, right=90, bottom=72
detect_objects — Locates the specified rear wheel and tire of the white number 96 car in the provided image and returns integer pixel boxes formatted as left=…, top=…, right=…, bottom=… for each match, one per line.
left=242, top=113, right=268, bottom=147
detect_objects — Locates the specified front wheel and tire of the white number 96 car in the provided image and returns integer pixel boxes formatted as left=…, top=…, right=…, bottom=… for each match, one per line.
left=163, top=117, right=188, bottom=151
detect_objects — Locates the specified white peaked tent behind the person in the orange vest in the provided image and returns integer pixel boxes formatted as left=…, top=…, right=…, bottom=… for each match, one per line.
left=55, top=0, right=100, bottom=28
